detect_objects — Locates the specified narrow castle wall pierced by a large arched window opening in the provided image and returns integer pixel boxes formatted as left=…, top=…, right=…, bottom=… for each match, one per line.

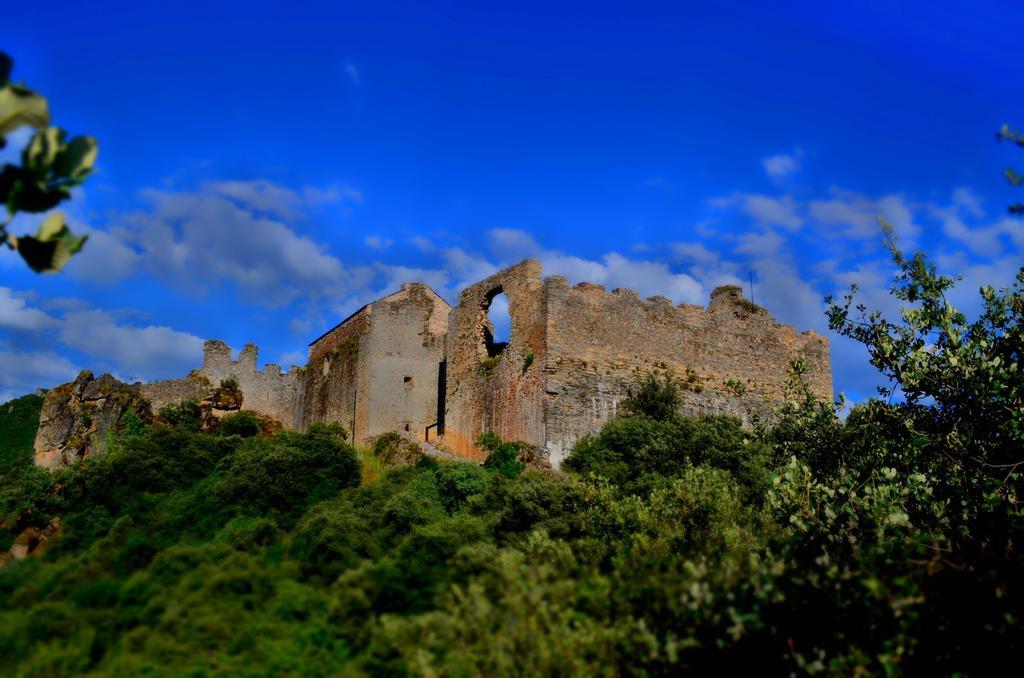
left=443, top=260, right=547, bottom=458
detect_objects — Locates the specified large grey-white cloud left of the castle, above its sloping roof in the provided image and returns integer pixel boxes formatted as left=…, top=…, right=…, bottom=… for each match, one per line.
left=61, top=179, right=364, bottom=307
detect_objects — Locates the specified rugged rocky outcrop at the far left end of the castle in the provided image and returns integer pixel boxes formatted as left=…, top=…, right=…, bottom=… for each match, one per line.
left=34, top=370, right=152, bottom=468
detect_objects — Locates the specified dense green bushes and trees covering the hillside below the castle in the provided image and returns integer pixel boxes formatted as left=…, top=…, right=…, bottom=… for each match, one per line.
left=0, top=248, right=1024, bottom=676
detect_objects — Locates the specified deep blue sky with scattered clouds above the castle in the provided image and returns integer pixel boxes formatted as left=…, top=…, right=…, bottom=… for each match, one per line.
left=0, top=2, right=1024, bottom=400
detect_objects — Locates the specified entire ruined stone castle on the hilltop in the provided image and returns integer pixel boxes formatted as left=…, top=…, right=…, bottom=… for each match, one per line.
left=36, top=259, right=833, bottom=467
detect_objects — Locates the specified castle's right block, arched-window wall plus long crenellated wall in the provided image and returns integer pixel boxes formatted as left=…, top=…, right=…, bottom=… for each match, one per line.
left=444, top=260, right=833, bottom=466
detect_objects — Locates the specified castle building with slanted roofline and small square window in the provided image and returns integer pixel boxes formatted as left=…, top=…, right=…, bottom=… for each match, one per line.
left=302, top=283, right=452, bottom=441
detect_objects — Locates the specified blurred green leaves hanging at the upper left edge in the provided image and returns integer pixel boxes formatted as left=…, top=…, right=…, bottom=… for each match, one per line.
left=0, top=52, right=98, bottom=273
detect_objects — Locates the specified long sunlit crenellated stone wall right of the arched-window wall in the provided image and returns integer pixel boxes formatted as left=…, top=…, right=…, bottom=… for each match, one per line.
left=544, top=276, right=833, bottom=465
